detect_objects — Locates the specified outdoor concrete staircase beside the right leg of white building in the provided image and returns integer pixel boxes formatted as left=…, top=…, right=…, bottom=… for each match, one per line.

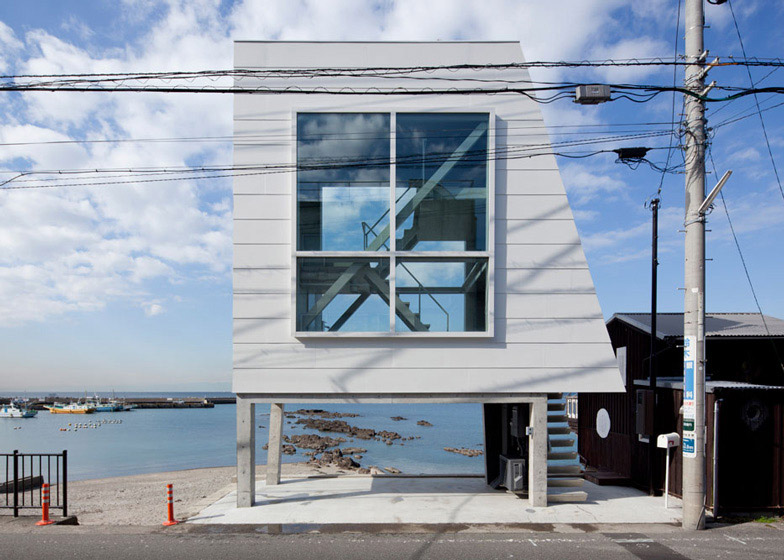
left=547, top=393, right=588, bottom=503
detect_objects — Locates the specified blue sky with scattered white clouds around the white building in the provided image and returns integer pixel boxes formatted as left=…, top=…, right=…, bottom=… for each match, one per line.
left=0, top=0, right=784, bottom=391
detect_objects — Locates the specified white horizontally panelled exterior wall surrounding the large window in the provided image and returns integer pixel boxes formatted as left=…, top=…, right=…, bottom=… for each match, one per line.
left=234, top=42, right=623, bottom=399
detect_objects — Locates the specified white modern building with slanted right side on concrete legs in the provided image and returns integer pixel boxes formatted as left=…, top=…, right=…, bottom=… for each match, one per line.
left=233, top=41, right=623, bottom=506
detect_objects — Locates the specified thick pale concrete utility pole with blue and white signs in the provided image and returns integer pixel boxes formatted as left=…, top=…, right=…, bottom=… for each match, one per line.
left=681, top=0, right=707, bottom=530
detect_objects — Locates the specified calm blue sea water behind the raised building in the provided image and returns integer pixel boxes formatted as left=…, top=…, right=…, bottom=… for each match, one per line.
left=0, top=393, right=484, bottom=480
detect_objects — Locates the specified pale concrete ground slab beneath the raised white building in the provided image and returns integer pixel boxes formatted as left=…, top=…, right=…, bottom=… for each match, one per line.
left=188, top=477, right=681, bottom=525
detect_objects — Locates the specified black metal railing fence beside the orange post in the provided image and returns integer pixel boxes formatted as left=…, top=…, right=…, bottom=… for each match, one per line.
left=0, top=450, right=68, bottom=517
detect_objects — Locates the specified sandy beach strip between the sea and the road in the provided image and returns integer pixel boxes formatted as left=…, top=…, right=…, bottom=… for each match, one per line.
left=63, top=463, right=338, bottom=526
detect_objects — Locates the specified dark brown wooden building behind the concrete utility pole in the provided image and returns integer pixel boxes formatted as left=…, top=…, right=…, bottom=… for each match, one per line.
left=578, top=313, right=784, bottom=512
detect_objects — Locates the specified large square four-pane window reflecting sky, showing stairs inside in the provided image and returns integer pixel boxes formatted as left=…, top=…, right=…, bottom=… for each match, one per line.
left=295, top=113, right=492, bottom=336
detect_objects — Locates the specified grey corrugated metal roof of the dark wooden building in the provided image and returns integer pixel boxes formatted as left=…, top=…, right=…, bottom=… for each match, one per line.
left=608, top=313, right=784, bottom=338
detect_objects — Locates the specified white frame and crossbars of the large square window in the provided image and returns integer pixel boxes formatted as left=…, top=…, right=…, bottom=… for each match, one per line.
left=290, top=107, right=496, bottom=339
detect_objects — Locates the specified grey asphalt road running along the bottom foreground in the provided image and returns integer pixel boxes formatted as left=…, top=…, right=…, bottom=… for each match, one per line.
left=0, top=523, right=784, bottom=560
